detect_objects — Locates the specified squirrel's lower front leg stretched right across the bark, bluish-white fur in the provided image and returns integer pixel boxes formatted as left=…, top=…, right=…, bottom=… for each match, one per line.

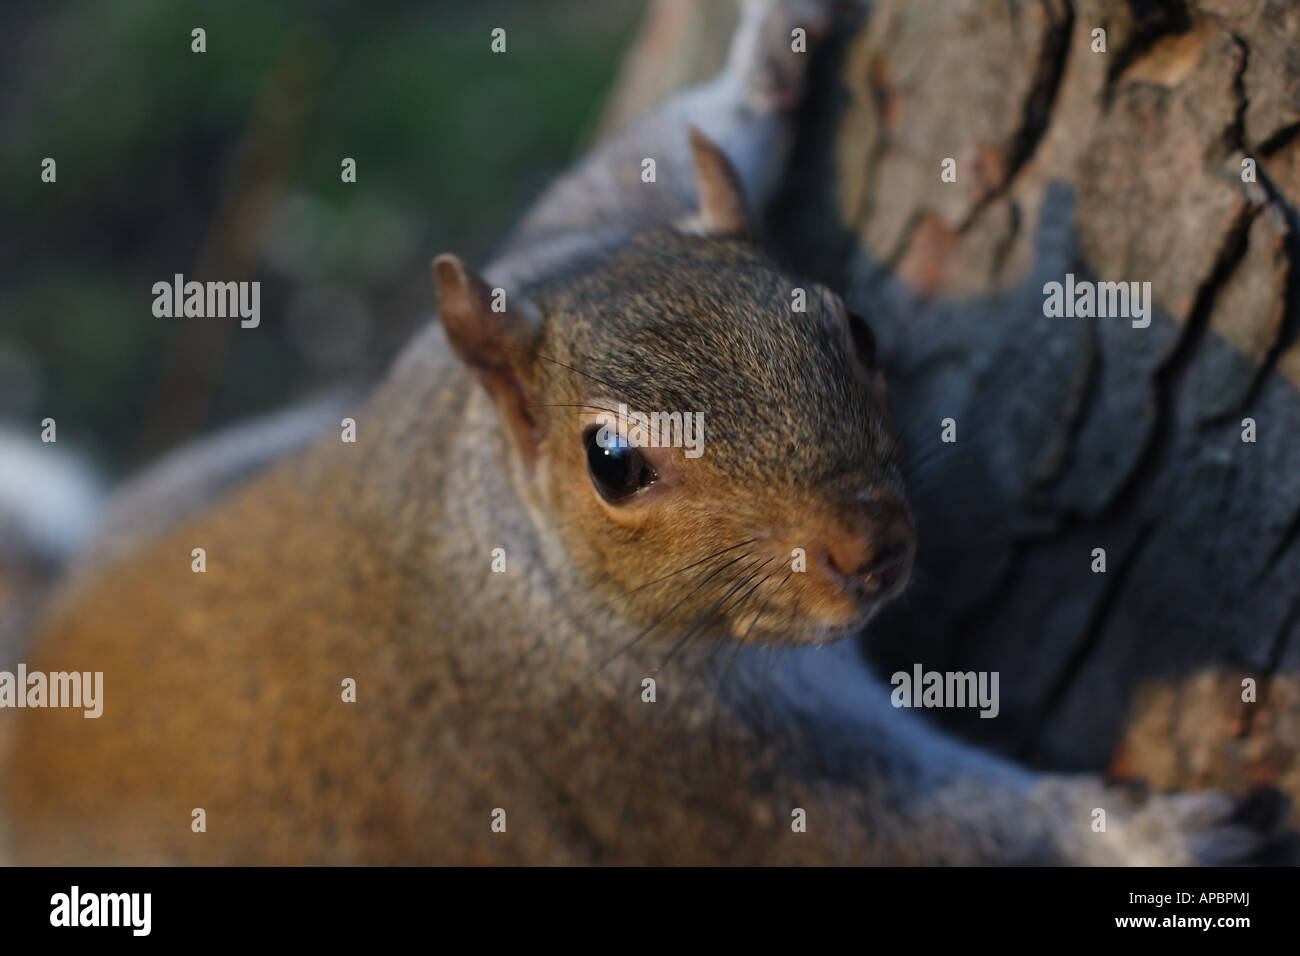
left=731, top=643, right=1296, bottom=865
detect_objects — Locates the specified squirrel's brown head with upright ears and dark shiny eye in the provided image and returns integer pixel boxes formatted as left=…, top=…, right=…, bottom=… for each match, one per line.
left=434, top=131, right=915, bottom=643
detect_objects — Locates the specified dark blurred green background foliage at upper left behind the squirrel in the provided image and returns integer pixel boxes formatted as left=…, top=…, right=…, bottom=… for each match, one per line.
left=0, top=0, right=641, bottom=468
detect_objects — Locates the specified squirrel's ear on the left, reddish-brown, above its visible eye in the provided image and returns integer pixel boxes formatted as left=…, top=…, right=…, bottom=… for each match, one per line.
left=433, top=254, right=538, bottom=460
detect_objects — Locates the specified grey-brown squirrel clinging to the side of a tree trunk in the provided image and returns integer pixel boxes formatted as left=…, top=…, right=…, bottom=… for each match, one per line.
left=0, top=3, right=1277, bottom=864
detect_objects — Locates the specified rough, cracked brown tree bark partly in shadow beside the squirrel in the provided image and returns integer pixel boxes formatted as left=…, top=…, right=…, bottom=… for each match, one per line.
left=608, top=0, right=1300, bottom=819
